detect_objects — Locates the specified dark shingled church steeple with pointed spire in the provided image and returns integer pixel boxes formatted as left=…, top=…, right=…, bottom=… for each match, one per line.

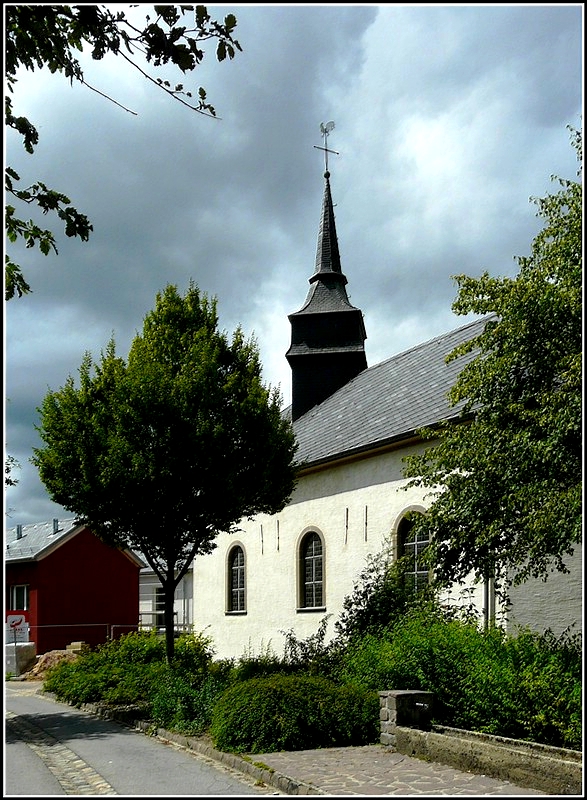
left=286, top=171, right=367, bottom=421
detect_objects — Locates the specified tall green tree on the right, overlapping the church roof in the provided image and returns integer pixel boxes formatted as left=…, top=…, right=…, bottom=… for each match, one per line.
left=405, top=129, right=583, bottom=596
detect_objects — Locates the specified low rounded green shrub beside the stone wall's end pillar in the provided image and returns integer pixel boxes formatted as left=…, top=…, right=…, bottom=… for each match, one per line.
left=210, top=675, right=379, bottom=753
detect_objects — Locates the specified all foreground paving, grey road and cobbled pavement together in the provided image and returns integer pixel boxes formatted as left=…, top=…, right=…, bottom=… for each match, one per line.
left=4, top=682, right=544, bottom=797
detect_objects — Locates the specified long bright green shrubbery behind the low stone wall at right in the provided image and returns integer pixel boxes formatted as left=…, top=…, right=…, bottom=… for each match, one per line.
left=339, top=604, right=582, bottom=749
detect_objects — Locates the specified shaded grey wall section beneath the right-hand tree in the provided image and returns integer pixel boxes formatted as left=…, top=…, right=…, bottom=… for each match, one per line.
left=507, top=545, right=583, bottom=636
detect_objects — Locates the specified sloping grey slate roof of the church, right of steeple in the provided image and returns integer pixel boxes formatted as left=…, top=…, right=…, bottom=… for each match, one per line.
left=294, top=316, right=490, bottom=467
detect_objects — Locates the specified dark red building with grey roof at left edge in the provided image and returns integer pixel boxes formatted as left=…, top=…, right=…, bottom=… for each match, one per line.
left=5, top=519, right=144, bottom=655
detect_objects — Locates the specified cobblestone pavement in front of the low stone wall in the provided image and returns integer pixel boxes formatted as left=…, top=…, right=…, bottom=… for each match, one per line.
left=247, top=745, right=545, bottom=797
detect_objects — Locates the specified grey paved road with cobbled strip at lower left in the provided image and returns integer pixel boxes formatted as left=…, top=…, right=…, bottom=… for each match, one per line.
left=3, top=681, right=281, bottom=797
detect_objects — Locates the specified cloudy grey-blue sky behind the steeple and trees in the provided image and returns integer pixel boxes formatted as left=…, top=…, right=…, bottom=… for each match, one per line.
left=5, top=4, right=583, bottom=527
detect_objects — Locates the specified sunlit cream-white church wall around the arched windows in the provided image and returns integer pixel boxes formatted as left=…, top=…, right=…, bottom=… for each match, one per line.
left=194, top=448, right=483, bottom=658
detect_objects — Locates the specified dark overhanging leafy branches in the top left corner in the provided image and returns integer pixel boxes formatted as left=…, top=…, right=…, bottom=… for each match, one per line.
left=4, top=4, right=241, bottom=300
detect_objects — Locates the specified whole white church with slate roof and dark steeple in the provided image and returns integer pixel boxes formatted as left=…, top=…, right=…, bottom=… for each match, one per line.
left=140, top=169, right=582, bottom=658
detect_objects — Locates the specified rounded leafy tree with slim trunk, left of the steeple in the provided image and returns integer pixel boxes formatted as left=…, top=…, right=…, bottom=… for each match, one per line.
left=31, top=284, right=296, bottom=660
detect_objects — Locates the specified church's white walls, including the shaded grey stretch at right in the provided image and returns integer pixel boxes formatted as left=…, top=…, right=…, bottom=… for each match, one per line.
left=141, top=446, right=582, bottom=658
